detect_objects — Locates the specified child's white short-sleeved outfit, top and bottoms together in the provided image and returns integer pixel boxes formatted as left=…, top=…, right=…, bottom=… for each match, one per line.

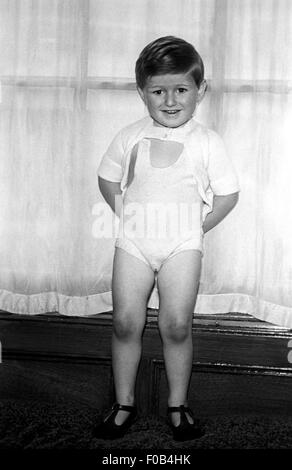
left=98, top=117, right=239, bottom=271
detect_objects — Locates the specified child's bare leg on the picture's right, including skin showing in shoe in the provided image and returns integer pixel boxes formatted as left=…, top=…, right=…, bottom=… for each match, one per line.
left=158, top=250, right=201, bottom=425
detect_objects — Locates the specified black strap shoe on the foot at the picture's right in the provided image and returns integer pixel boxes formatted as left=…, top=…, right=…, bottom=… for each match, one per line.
left=167, top=405, right=205, bottom=441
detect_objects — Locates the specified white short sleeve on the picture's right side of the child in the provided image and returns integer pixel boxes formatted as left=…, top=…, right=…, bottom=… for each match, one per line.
left=207, top=130, right=240, bottom=196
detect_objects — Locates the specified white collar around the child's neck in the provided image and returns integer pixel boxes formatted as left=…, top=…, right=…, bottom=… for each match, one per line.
left=144, top=119, right=196, bottom=143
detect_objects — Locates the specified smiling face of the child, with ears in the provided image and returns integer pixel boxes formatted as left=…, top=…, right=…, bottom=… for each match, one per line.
left=138, top=73, right=206, bottom=127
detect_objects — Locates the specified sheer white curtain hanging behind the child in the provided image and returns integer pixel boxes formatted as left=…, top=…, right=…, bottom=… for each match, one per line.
left=0, top=0, right=292, bottom=327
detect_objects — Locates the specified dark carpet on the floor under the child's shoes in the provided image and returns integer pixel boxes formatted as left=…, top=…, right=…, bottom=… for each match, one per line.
left=0, top=399, right=292, bottom=450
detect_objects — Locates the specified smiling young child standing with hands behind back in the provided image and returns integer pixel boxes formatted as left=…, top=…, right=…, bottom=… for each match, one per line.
left=94, top=36, right=239, bottom=440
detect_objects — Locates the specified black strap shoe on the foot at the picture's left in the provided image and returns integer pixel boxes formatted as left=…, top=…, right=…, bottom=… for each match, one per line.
left=93, top=403, right=137, bottom=439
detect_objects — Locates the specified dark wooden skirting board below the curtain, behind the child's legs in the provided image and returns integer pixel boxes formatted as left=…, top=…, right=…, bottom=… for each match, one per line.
left=0, top=311, right=292, bottom=416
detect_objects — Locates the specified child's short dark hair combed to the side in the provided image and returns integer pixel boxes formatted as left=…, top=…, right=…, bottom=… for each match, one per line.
left=135, top=36, right=204, bottom=89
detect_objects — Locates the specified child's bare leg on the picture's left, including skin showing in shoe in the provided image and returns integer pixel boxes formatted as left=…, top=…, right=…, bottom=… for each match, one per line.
left=112, top=248, right=154, bottom=424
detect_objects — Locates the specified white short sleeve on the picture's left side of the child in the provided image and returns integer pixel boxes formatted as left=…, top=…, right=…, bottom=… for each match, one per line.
left=97, top=132, right=124, bottom=183
